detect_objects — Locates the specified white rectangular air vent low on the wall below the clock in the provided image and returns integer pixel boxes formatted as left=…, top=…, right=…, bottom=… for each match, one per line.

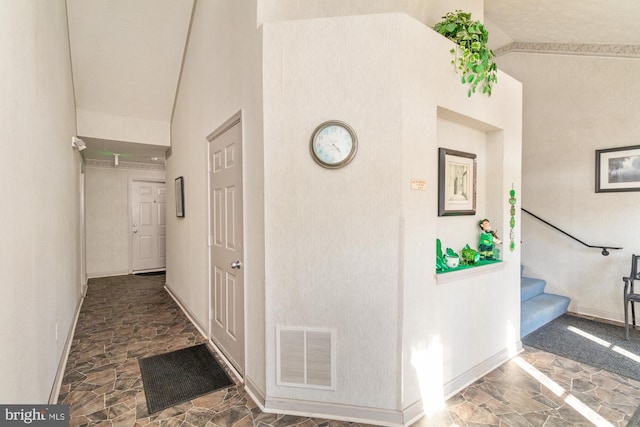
left=276, top=326, right=336, bottom=390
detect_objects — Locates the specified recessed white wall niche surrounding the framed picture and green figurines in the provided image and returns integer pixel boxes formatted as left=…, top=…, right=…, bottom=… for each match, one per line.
left=434, top=107, right=509, bottom=284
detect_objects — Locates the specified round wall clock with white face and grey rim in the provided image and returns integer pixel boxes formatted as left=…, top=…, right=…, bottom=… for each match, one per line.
left=309, top=120, right=358, bottom=169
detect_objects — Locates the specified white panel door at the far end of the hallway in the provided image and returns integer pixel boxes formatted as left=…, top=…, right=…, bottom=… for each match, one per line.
left=131, top=181, right=167, bottom=272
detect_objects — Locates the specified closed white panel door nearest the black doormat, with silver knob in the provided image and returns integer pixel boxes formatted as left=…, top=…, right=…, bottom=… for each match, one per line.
left=209, top=122, right=244, bottom=374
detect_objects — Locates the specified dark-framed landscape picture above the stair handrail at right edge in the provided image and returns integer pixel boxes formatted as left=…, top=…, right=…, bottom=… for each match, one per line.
left=596, top=145, right=640, bottom=193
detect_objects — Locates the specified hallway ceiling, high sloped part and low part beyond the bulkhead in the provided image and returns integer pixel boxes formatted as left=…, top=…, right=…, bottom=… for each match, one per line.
left=67, top=0, right=193, bottom=163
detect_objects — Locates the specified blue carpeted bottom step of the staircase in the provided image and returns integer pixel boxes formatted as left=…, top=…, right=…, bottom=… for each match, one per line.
left=520, top=293, right=571, bottom=337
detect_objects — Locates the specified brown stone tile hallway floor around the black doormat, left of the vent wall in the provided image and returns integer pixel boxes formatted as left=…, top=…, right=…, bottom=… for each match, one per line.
left=58, top=274, right=378, bottom=427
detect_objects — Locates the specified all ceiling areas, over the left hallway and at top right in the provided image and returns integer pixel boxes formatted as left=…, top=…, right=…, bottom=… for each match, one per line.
left=67, top=0, right=640, bottom=163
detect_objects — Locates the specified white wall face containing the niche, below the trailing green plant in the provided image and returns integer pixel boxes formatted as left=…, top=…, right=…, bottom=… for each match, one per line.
left=398, top=18, right=522, bottom=414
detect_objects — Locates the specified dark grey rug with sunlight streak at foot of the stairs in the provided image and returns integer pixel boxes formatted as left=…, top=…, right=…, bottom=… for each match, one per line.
left=522, top=314, right=640, bottom=381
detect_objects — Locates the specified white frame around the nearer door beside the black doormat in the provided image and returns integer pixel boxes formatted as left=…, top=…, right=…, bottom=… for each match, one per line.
left=205, top=110, right=247, bottom=382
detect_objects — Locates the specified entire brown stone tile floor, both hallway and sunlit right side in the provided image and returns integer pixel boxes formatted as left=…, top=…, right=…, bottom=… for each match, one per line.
left=59, top=275, right=640, bottom=427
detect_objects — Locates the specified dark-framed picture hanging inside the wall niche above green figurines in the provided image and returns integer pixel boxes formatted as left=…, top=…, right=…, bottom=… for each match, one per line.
left=438, top=148, right=477, bottom=216
